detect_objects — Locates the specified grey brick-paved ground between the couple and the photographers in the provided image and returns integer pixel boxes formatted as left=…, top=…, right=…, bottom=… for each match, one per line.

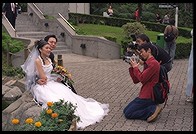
left=56, top=54, right=193, bottom=131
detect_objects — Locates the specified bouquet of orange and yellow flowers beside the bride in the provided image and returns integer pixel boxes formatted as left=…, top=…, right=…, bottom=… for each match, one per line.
left=51, top=65, right=74, bottom=85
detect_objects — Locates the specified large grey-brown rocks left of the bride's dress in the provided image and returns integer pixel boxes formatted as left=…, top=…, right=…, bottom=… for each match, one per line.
left=2, top=77, right=42, bottom=131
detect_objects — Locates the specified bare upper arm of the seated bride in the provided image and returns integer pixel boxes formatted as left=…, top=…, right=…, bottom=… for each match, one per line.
left=35, top=59, right=47, bottom=81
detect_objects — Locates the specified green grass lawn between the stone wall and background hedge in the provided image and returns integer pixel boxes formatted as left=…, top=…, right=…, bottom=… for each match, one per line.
left=74, top=24, right=191, bottom=44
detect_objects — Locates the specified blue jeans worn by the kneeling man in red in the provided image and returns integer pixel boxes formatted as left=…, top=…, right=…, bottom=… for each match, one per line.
left=123, top=97, right=156, bottom=120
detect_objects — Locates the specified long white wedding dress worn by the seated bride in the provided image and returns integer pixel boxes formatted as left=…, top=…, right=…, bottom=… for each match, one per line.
left=32, top=56, right=109, bottom=129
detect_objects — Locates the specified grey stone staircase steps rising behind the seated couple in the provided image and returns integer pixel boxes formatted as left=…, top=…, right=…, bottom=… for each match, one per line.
left=16, top=12, right=71, bottom=55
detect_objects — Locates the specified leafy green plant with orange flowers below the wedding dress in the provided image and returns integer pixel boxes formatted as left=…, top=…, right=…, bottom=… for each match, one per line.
left=14, top=100, right=80, bottom=131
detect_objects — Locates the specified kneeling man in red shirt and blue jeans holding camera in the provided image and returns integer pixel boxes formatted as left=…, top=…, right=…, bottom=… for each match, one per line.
left=123, top=42, right=162, bottom=123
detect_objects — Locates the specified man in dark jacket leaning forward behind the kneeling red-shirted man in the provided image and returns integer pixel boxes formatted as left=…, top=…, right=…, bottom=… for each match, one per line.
left=127, top=34, right=172, bottom=72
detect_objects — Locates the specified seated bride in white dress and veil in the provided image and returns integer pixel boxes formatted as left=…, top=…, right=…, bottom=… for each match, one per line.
left=21, top=40, right=109, bottom=129
